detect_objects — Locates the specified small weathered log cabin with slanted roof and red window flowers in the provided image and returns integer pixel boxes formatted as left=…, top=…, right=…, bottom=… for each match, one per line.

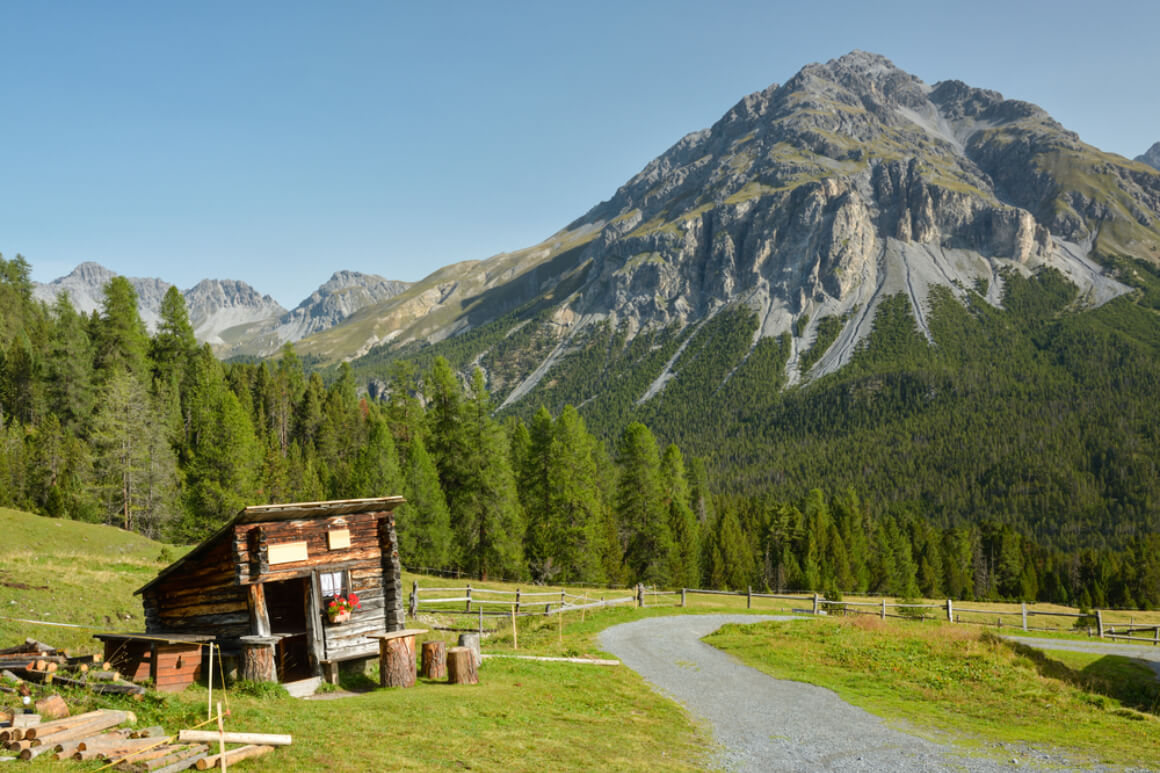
left=137, top=497, right=404, bottom=682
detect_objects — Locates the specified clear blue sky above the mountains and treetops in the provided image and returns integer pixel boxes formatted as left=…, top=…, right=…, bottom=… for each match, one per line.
left=0, top=0, right=1160, bottom=308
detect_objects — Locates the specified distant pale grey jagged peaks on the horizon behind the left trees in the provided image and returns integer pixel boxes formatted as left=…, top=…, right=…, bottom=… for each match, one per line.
left=32, top=262, right=407, bottom=357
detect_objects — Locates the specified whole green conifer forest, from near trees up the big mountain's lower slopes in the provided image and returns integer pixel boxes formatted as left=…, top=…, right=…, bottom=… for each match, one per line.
left=0, top=257, right=1160, bottom=606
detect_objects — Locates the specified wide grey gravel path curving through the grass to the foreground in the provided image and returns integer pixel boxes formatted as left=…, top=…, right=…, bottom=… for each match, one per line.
left=600, top=615, right=1067, bottom=773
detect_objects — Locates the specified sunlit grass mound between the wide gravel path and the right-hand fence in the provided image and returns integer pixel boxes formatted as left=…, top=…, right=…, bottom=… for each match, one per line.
left=705, top=617, right=1160, bottom=767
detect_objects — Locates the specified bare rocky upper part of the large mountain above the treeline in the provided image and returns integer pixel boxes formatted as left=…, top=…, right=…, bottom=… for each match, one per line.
left=303, top=51, right=1160, bottom=396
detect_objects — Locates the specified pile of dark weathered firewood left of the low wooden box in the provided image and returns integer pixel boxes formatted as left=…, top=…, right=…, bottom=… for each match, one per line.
left=0, top=638, right=145, bottom=696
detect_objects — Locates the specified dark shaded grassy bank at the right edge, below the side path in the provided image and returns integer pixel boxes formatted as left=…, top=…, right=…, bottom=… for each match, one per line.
left=986, top=634, right=1160, bottom=718
